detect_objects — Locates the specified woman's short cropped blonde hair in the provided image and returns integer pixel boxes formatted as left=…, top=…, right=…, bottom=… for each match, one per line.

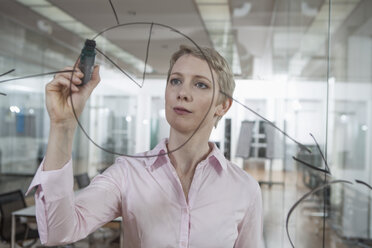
left=167, top=45, right=235, bottom=127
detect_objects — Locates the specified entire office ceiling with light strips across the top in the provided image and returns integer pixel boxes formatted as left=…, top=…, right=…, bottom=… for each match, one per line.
left=0, top=0, right=372, bottom=81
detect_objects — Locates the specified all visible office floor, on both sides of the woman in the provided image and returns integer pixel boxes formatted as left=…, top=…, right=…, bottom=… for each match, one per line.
left=0, top=165, right=372, bottom=248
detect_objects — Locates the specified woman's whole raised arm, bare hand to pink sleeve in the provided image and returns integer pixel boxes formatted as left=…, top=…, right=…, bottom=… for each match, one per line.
left=28, top=66, right=125, bottom=245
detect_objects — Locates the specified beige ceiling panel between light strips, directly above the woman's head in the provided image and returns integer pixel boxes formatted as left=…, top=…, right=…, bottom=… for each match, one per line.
left=50, top=0, right=212, bottom=74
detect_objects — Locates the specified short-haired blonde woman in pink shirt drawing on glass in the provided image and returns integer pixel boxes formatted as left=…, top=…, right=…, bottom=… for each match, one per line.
left=30, top=46, right=262, bottom=248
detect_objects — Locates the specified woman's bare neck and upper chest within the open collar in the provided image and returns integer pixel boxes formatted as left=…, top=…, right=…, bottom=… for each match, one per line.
left=168, top=130, right=211, bottom=175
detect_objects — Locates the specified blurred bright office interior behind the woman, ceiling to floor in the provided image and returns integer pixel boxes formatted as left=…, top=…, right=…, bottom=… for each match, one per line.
left=0, top=0, right=372, bottom=247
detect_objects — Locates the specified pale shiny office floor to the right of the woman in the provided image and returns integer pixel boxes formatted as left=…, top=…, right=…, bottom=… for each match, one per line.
left=245, top=161, right=372, bottom=248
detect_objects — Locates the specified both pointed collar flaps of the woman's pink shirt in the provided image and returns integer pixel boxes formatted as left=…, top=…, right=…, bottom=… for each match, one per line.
left=146, top=139, right=227, bottom=170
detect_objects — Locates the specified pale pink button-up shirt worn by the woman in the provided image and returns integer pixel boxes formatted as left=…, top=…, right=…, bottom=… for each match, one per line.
left=29, top=140, right=262, bottom=248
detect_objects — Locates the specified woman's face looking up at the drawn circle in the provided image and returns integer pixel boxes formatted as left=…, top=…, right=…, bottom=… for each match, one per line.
left=165, top=55, right=221, bottom=135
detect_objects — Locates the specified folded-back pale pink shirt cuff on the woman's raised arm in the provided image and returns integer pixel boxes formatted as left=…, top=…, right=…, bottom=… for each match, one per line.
left=26, top=159, right=74, bottom=202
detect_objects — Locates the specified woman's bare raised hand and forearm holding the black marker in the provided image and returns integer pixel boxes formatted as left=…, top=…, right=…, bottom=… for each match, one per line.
left=43, top=66, right=100, bottom=171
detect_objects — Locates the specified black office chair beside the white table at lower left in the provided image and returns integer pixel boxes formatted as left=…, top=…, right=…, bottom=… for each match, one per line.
left=0, top=190, right=39, bottom=247
